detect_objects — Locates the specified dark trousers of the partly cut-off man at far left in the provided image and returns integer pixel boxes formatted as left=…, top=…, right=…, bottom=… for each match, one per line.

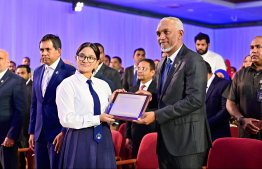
left=0, top=143, right=18, bottom=169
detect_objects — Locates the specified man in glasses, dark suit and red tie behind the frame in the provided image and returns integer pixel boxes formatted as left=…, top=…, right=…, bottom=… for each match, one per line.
left=125, top=59, right=157, bottom=158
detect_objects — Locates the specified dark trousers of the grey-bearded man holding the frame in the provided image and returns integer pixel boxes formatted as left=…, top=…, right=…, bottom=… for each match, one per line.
left=158, top=133, right=206, bottom=169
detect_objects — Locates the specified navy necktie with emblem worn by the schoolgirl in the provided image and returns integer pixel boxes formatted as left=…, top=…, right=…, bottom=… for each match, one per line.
left=86, top=80, right=103, bottom=143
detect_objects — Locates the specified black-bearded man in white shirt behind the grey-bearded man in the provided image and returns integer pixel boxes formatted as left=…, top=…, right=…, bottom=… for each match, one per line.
left=195, top=32, right=226, bottom=72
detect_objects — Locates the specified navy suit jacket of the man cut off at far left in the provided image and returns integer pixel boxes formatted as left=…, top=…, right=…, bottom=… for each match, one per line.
left=0, top=70, right=27, bottom=144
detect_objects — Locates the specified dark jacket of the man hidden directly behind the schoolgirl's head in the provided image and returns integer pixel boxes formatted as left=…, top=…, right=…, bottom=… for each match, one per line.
left=95, top=63, right=122, bottom=90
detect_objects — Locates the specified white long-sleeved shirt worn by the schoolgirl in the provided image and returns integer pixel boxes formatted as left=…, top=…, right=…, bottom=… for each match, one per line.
left=56, top=71, right=112, bottom=129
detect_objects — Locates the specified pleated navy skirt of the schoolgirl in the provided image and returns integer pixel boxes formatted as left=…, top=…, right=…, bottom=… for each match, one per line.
left=59, top=123, right=116, bottom=169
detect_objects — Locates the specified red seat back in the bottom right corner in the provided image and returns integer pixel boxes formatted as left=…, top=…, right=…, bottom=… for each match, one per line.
left=207, top=137, right=262, bottom=169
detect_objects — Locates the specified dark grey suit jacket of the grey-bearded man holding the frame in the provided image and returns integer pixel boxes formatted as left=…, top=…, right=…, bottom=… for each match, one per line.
left=155, top=44, right=212, bottom=156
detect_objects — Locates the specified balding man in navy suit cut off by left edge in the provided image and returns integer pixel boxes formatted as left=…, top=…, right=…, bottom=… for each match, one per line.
left=0, top=49, right=27, bottom=168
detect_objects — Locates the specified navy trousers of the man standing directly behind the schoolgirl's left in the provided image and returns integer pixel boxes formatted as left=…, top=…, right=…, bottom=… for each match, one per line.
left=35, top=129, right=60, bottom=169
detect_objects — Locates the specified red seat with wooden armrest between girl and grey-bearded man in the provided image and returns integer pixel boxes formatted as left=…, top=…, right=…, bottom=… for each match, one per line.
left=116, top=133, right=159, bottom=169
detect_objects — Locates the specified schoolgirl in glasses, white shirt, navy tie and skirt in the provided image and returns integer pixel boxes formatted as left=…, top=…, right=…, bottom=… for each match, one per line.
left=56, top=42, right=116, bottom=169
